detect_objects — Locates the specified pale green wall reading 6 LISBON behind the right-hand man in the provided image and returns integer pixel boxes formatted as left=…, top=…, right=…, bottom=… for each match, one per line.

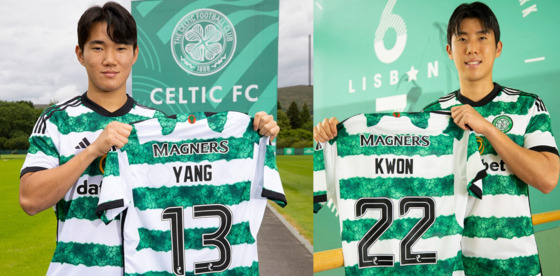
left=313, top=0, right=560, bottom=275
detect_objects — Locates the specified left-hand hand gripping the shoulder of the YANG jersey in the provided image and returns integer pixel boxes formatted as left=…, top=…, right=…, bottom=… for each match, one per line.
left=89, top=121, right=132, bottom=157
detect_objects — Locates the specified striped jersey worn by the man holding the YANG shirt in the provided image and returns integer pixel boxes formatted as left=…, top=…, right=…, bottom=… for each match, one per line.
left=21, top=94, right=164, bottom=275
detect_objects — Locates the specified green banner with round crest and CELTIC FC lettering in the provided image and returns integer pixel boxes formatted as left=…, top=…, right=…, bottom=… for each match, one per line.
left=132, top=0, right=279, bottom=115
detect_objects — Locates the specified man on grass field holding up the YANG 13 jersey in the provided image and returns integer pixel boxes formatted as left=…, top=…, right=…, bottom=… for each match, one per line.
left=20, top=2, right=279, bottom=275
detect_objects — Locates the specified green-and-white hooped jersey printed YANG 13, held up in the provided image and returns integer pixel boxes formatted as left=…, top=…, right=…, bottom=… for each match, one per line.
left=98, top=112, right=286, bottom=275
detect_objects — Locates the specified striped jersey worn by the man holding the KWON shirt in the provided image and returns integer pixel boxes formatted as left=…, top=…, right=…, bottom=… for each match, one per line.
left=425, top=84, right=558, bottom=275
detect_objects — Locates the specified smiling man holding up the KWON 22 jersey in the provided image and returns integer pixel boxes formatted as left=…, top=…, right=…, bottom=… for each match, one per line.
left=314, top=2, right=560, bottom=275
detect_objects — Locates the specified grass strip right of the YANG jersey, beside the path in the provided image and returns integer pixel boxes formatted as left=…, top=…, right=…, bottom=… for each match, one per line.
left=272, top=155, right=313, bottom=244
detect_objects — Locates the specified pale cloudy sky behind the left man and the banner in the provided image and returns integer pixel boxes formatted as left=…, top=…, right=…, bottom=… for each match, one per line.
left=0, top=0, right=313, bottom=104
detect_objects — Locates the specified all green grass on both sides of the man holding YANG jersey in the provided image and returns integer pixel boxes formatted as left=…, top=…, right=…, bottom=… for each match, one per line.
left=0, top=155, right=313, bottom=275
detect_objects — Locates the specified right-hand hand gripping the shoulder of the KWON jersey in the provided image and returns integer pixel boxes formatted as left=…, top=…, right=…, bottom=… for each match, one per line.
left=451, top=104, right=494, bottom=135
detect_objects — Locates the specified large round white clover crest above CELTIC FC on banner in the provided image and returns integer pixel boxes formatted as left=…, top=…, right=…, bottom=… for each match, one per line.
left=171, top=9, right=237, bottom=76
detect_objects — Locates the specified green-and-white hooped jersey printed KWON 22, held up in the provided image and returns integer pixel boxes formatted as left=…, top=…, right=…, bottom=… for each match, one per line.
left=314, top=112, right=485, bottom=275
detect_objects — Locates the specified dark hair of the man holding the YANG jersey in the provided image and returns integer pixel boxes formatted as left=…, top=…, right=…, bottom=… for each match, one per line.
left=78, top=2, right=137, bottom=50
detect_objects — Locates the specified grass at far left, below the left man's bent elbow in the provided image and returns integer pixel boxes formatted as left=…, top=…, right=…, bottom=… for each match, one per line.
left=0, top=155, right=56, bottom=275
